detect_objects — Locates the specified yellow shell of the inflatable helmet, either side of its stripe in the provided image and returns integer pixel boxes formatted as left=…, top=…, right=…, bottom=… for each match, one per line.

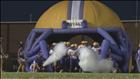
left=35, top=1, right=123, bottom=29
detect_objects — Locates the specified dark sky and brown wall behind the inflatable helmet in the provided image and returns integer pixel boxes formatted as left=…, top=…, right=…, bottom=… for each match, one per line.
left=0, top=0, right=140, bottom=71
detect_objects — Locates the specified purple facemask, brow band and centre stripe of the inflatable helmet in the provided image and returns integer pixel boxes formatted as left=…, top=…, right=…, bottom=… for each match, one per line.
left=24, top=1, right=132, bottom=72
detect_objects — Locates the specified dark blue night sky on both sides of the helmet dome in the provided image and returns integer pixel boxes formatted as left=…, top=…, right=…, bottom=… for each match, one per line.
left=1, top=0, right=140, bottom=22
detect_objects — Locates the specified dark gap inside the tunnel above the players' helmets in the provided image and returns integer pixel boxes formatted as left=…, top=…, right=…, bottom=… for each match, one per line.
left=46, top=33, right=103, bottom=45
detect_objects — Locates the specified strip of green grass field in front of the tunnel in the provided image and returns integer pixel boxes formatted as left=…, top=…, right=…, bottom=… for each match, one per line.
left=1, top=72, right=140, bottom=79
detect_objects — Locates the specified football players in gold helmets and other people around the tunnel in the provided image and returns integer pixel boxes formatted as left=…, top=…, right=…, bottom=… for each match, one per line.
left=17, top=41, right=140, bottom=73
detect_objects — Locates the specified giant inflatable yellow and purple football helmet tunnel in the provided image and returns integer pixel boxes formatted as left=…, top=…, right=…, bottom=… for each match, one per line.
left=24, top=1, right=131, bottom=72
